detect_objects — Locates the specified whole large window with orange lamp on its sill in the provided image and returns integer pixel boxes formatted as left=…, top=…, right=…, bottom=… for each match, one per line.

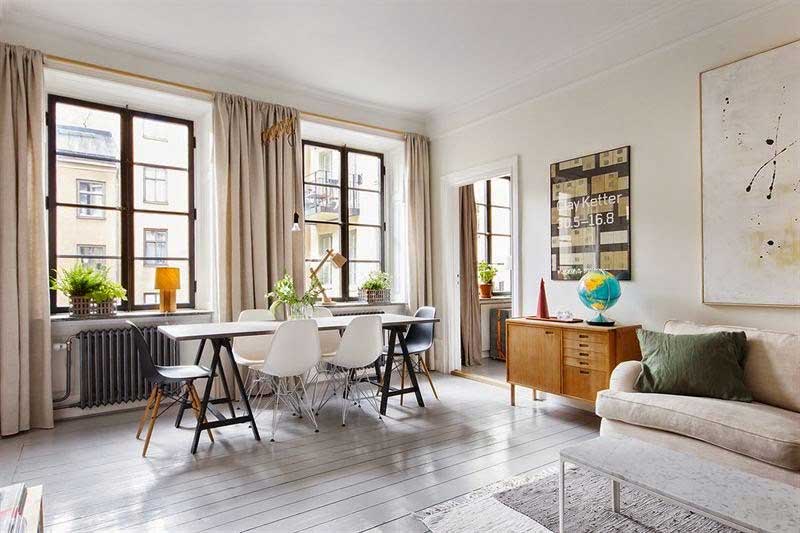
left=47, top=95, right=196, bottom=313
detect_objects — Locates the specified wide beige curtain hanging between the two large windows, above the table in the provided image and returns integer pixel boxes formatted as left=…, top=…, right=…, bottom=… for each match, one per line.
left=214, top=94, right=304, bottom=320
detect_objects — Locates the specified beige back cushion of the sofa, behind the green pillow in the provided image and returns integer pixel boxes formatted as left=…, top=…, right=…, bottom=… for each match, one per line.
left=664, top=320, right=800, bottom=412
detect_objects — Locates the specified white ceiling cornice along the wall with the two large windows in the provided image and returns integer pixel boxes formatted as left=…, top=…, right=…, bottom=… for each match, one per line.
left=0, top=7, right=426, bottom=125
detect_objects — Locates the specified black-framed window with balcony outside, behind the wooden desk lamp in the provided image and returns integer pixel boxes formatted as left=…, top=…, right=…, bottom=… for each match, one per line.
left=303, top=141, right=385, bottom=300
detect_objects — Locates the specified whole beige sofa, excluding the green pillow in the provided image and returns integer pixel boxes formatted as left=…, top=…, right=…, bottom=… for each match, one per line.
left=595, top=321, right=800, bottom=487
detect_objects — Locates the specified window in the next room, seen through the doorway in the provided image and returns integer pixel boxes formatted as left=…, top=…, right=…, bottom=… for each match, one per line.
left=473, top=178, right=511, bottom=295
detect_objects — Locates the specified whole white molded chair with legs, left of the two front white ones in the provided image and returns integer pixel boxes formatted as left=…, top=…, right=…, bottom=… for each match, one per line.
left=255, top=319, right=321, bottom=442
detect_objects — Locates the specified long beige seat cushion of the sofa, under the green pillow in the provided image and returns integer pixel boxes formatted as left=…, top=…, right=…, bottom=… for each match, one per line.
left=595, top=390, right=800, bottom=470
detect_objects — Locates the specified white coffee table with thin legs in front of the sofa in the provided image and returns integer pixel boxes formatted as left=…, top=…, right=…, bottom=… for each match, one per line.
left=558, top=437, right=800, bottom=533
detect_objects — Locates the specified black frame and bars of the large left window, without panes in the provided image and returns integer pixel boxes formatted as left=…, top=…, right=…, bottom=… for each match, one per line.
left=46, top=94, right=197, bottom=314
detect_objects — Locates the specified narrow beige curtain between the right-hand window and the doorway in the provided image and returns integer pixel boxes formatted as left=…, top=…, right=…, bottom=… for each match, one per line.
left=405, top=133, right=442, bottom=369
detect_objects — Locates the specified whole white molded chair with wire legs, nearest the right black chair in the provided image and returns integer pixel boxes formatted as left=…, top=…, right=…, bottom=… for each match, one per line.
left=330, top=315, right=383, bottom=426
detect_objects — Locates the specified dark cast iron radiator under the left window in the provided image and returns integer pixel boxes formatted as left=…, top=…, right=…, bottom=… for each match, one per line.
left=76, top=327, right=180, bottom=409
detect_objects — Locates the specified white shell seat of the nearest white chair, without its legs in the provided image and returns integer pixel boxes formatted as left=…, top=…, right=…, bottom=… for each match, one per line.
left=262, top=319, right=322, bottom=377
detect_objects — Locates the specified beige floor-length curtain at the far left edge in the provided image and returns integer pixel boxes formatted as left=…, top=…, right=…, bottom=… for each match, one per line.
left=0, top=43, right=53, bottom=436
